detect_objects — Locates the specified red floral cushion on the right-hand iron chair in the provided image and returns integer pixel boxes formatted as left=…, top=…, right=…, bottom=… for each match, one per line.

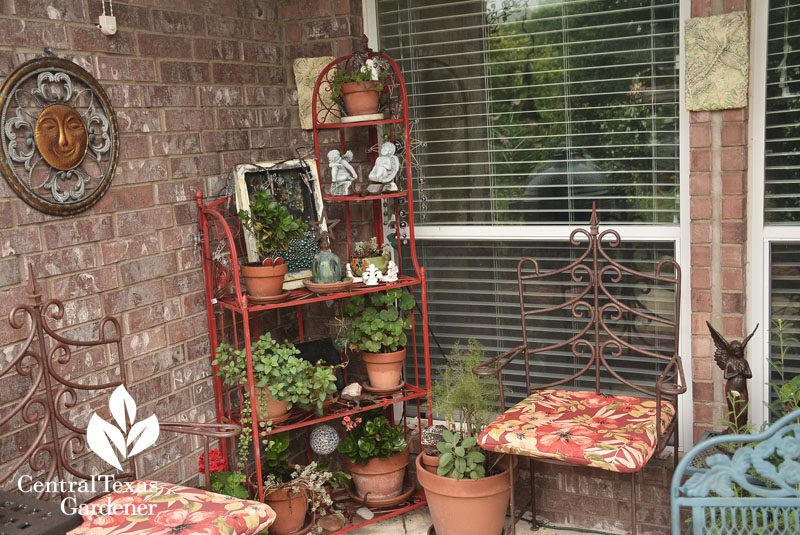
left=478, top=390, right=675, bottom=472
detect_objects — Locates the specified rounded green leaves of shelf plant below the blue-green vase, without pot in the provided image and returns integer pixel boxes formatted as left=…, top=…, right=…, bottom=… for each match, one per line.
left=342, top=288, right=416, bottom=353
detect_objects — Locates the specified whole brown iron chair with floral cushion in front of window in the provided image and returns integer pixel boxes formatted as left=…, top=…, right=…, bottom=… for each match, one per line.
left=473, top=207, right=686, bottom=534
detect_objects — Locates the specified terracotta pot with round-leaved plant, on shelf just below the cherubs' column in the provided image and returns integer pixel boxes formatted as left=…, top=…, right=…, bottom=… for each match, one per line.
left=342, top=288, right=416, bottom=392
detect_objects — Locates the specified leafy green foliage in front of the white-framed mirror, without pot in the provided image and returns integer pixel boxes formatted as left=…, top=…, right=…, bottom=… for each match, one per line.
left=239, top=191, right=308, bottom=262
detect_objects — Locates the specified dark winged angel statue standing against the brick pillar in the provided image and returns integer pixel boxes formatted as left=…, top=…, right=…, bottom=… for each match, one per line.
left=706, top=322, right=758, bottom=433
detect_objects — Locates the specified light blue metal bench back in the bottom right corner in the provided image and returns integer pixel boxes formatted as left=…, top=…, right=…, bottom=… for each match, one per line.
left=670, top=410, right=800, bottom=535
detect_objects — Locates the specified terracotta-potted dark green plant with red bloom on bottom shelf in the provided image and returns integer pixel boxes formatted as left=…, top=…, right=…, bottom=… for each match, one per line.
left=339, top=411, right=408, bottom=500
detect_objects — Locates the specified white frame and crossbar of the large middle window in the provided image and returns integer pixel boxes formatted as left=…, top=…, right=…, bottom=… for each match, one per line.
left=362, top=0, right=694, bottom=451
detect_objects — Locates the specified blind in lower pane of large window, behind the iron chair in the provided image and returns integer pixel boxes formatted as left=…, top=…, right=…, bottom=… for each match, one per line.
left=406, top=241, right=675, bottom=406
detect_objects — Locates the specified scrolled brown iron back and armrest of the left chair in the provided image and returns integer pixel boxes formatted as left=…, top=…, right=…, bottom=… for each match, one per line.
left=0, top=266, right=276, bottom=531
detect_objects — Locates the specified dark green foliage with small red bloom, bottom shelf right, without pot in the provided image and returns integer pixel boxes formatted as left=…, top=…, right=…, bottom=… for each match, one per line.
left=339, top=414, right=408, bottom=464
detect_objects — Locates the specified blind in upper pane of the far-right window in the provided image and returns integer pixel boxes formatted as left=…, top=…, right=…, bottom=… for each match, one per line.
left=764, top=0, right=800, bottom=225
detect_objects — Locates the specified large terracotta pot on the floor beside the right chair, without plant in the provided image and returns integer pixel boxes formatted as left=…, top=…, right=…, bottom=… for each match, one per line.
left=417, top=455, right=510, bottom=535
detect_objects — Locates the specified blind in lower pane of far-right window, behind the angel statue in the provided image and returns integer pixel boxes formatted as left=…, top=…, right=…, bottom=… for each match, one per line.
left=769, top=242, right=800, bottom=414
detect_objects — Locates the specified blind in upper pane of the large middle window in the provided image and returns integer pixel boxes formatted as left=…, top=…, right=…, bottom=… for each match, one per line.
left=377, top=0, right=679, bottom=225
